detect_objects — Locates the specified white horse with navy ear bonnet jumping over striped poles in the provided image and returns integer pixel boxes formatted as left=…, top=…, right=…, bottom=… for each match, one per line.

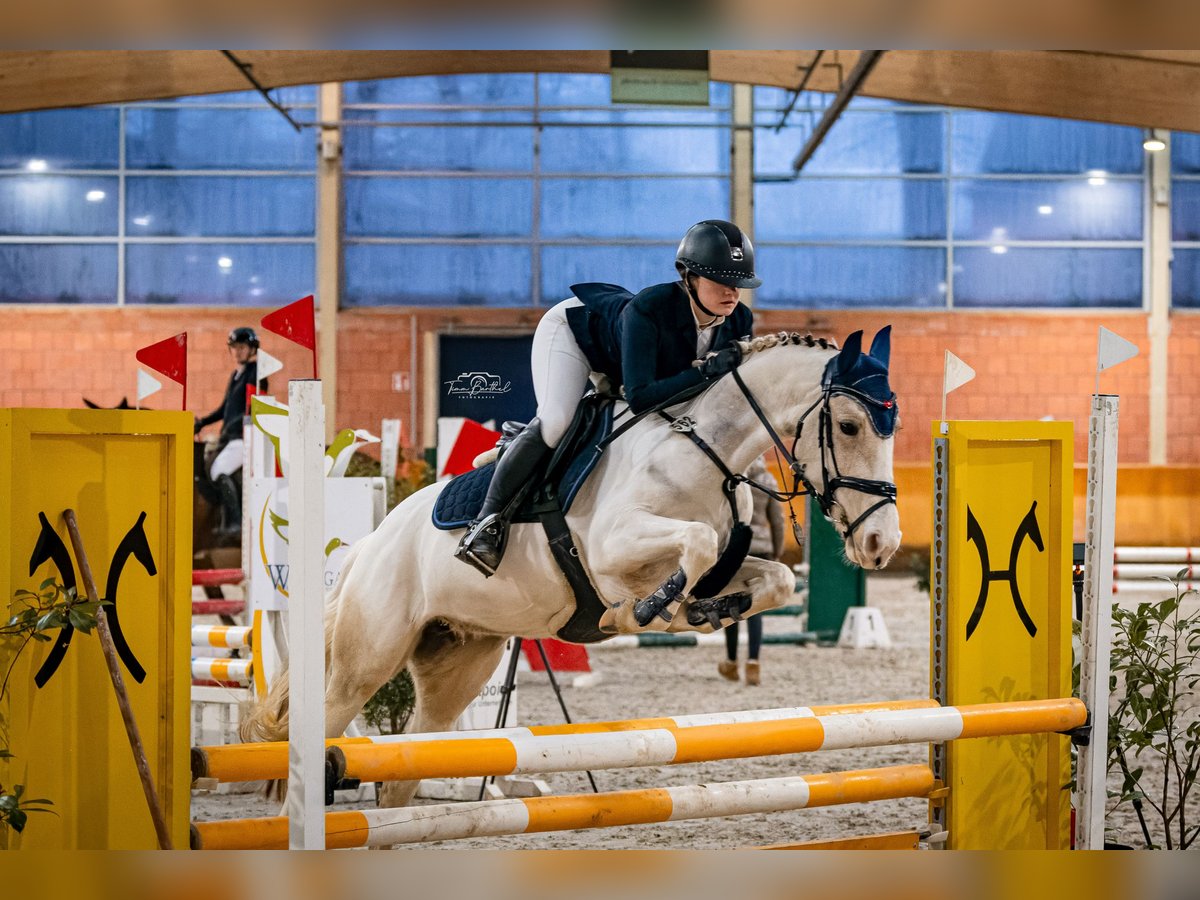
left=242, top=329, right=900, bottom=805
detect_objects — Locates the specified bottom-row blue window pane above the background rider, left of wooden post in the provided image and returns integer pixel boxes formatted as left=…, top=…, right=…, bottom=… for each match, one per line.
left=125, top=242, right=314, bottom=306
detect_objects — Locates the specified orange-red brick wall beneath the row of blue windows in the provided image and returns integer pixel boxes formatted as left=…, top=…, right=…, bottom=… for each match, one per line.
left=0, top=306, right=1200, bottom=466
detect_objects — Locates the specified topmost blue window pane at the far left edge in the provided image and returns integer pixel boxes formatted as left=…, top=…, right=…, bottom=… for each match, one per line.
left=0, top=109, right=121, bottom=169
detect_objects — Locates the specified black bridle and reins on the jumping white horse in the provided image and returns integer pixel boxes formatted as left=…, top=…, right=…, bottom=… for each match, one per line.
left=658, top=358, right=896, bottom=541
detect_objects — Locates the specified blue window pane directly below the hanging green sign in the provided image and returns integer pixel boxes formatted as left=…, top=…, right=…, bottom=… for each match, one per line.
left=541, top=126, right=730, bottom=175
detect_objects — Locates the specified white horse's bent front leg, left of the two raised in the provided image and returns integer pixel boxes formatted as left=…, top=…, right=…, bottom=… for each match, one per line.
left=588, top=512, right=720, bottom=635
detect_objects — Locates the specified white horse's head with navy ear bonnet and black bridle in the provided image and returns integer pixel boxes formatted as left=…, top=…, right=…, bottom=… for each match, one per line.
left=746, top=325, right=900, bottom=569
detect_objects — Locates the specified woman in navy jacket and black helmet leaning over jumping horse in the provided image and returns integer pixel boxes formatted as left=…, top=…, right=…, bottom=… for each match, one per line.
left=455, top=218, right=762, bottom=576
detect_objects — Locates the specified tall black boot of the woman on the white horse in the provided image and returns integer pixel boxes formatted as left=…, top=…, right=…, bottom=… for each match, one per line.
left=455, top=419, right=551, bottom=577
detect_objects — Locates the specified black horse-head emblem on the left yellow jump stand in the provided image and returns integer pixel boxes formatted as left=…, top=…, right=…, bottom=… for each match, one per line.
left=29, top=512, right=158, bottom=688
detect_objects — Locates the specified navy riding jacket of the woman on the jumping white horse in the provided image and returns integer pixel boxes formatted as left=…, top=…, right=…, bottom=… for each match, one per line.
left=566, top=281, right=754, bottom=413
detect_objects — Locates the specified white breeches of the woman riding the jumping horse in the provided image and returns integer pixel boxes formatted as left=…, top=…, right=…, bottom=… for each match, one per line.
left=533, top=296, right=592, bottom=448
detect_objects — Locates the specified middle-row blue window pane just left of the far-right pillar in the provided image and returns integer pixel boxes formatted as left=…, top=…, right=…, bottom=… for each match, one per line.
left=954, top=179, right=1142, bottom=240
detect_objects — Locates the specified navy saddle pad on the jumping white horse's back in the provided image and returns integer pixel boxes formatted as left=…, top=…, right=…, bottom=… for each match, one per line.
left=433, top=395, right=614, bottom=532
